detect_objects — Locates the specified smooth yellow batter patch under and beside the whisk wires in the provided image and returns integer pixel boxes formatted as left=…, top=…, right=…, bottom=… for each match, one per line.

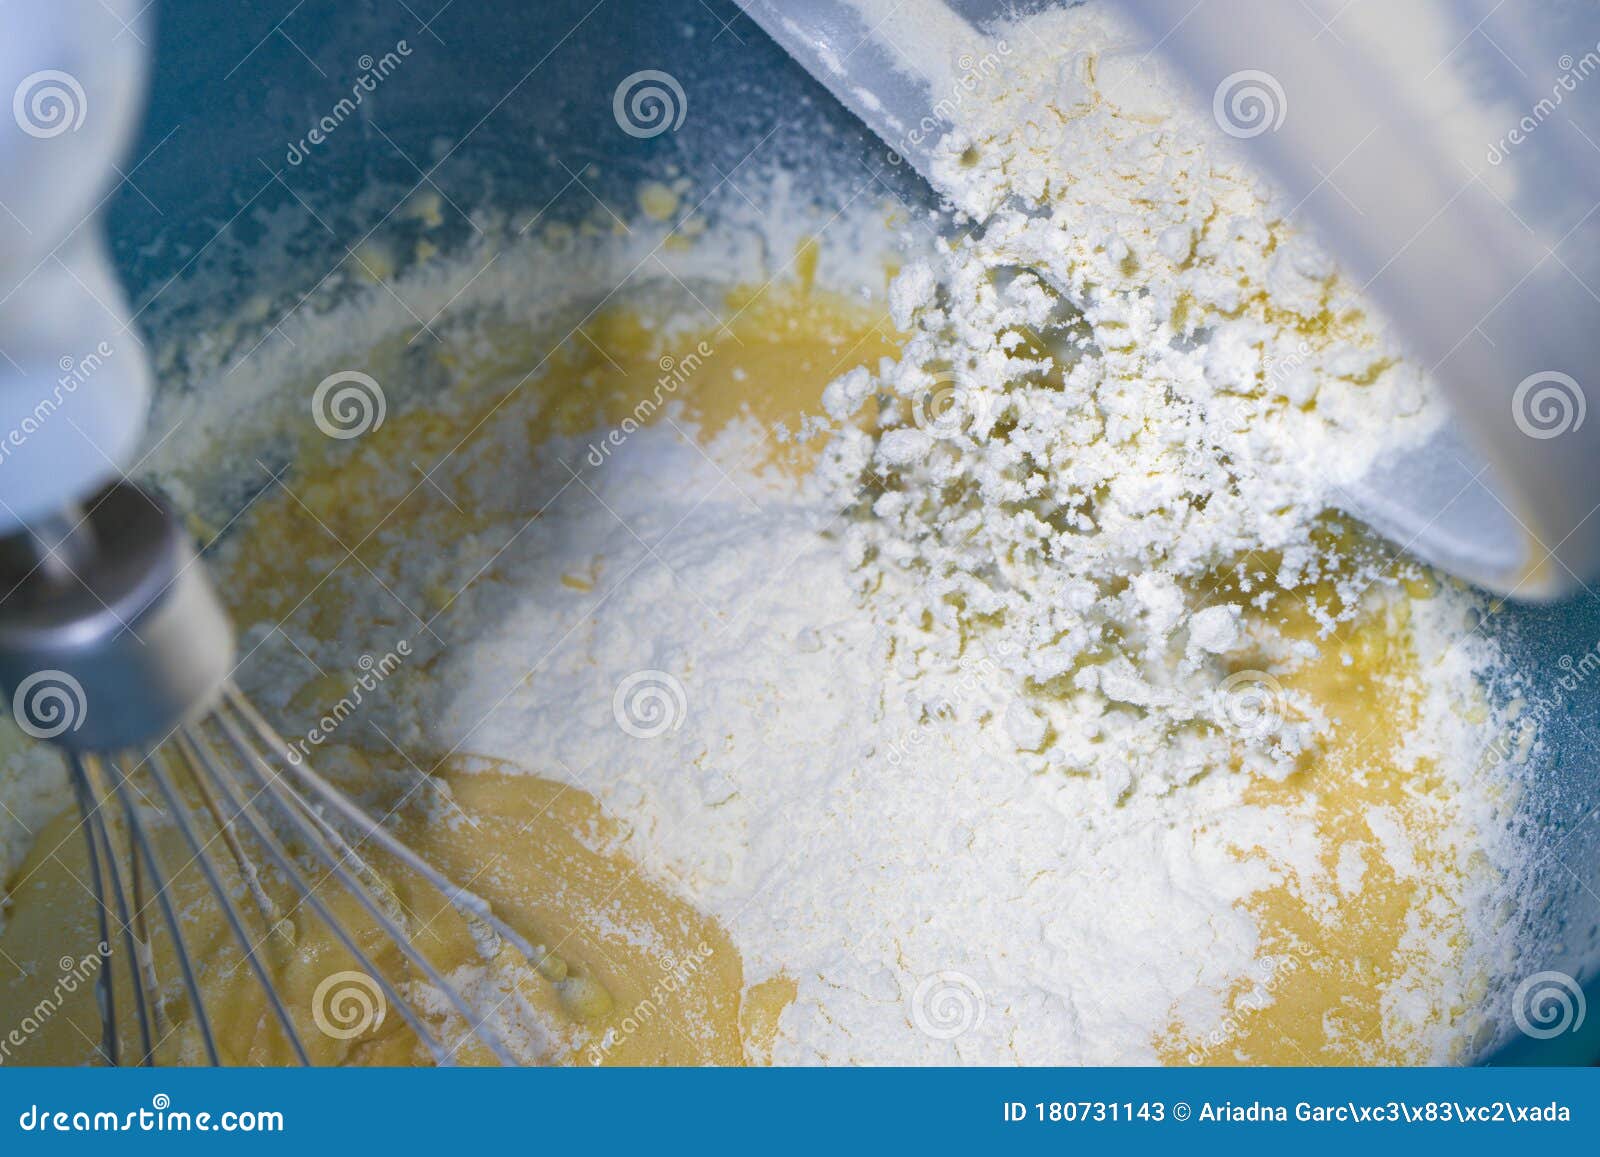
left=5, top=749, right=771, bottom=1064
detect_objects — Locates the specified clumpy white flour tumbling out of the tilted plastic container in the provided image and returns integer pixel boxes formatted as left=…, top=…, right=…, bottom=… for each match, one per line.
left=822, top=0, right=1438, bottom=791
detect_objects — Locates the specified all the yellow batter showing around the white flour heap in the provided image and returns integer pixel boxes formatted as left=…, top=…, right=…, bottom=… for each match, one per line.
left=0, top=260, right=1497, bottom=1064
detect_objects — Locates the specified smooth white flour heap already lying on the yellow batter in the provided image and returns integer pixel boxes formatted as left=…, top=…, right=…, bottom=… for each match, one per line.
left=331, top=427, right=1314, bottom=1064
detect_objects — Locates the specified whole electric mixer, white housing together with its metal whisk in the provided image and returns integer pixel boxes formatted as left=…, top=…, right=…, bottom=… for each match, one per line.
left=0, top=0, right=550, bottom=1064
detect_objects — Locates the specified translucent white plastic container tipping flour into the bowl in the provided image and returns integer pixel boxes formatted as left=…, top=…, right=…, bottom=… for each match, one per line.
left=746, top=0, right=1600, bottom=599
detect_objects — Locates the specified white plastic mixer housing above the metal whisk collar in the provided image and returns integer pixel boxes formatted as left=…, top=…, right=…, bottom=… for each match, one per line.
left=0, top=0, right=150, bottom=534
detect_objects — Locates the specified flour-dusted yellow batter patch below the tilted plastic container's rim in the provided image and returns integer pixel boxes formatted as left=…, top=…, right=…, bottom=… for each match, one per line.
left=1162, top=556, right=1486, bottom=1064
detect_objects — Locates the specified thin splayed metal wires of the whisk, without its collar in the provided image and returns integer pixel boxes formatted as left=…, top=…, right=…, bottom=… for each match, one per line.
left=60, top=685, right=542, bottom=1066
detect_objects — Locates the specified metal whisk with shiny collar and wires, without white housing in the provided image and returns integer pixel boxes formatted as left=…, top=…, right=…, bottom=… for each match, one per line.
left=0, top=482, right=549, bottom=1064
